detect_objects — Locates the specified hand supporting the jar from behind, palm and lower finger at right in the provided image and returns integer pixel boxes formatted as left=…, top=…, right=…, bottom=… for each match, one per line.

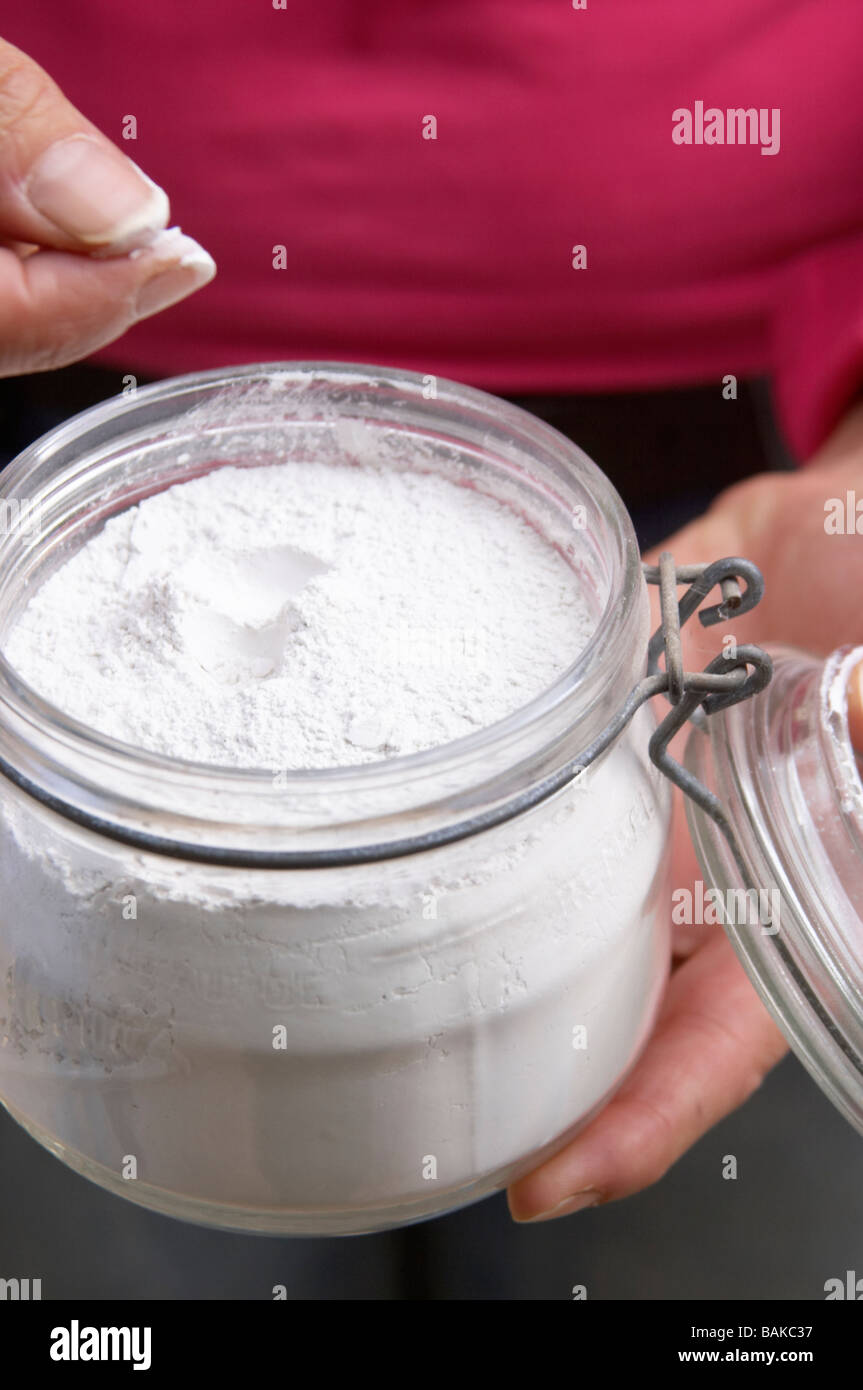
left=510, top=404, right=863, bottom=1220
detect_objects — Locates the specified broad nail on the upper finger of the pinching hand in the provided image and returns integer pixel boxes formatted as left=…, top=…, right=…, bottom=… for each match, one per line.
left=25, top=135, right=170, bottom=253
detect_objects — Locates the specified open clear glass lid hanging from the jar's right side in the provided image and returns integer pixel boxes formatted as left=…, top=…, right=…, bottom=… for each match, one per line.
left=685, top=648, right=863, bottom=1133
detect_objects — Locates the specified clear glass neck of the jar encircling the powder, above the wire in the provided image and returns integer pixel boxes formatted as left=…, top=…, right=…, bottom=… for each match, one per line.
left=0, top=363, right=648, bottom=853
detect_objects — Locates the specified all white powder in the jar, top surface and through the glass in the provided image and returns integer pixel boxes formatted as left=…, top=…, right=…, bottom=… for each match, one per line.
left=0, top=463, right=668, bottom=1232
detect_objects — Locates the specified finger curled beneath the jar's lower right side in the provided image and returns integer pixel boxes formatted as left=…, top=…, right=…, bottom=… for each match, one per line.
left=510, top=929, right=785, bottom=1220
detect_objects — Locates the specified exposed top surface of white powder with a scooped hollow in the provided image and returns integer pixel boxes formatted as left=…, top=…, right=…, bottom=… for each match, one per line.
left=7, top=461, right=593, bottom=770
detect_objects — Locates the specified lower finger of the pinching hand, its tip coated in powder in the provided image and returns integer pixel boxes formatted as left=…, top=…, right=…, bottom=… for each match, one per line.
left=0, top=228, right=215, bottom=377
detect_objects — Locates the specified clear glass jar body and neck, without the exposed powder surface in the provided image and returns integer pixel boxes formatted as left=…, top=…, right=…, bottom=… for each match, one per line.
left=0, top=364, right=670, bottom=1234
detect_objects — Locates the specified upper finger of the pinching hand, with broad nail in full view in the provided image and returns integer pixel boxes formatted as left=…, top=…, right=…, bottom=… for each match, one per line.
left=0, top=40, right=170, bottom=254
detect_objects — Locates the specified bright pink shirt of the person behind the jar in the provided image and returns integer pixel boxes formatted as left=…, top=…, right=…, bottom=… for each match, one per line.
left=3, top=0, right=863, bottom=456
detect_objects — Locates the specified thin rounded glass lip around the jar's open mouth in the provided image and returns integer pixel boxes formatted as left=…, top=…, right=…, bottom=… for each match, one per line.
left=0, top=361, right=646, bottom=856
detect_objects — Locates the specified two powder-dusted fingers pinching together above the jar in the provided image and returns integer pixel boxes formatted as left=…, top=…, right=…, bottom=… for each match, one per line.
left=0, top=40, right=215, bottom=377
